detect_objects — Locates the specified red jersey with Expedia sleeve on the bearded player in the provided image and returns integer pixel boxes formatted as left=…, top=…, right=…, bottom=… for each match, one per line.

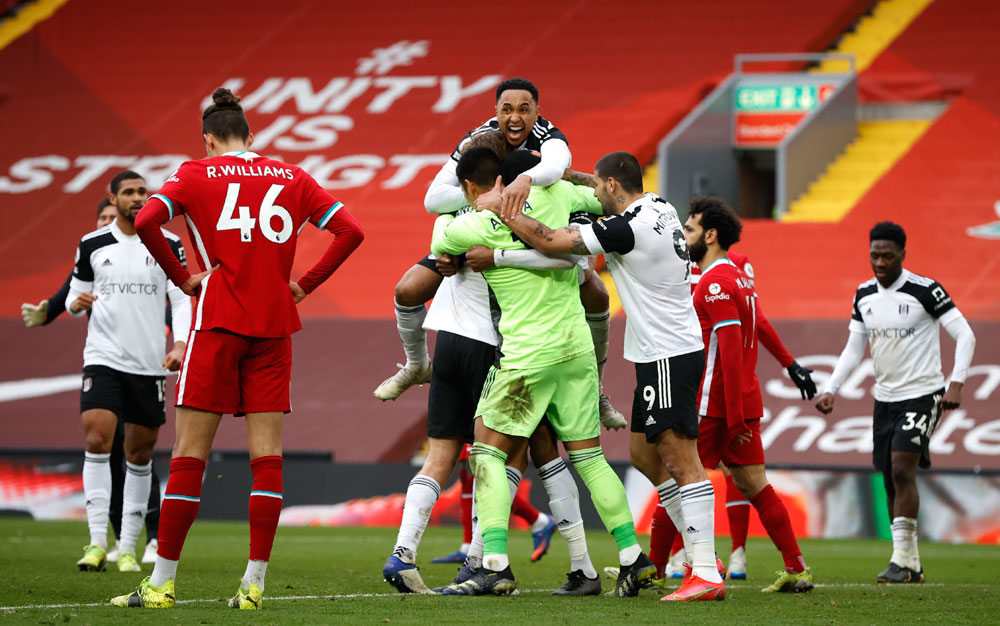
left=694, top=259, right=764, bottom=427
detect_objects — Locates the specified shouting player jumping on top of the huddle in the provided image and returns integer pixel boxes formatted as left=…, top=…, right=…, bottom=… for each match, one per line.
left=374, top=78, right=625, bottom=429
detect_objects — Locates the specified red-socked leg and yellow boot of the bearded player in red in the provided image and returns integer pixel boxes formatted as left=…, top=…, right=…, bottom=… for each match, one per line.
left=726, top=458, right=813, bottom=592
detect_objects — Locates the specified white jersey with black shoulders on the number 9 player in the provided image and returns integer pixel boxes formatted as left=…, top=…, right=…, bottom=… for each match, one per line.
left=580, top=194, right=704, bottom=363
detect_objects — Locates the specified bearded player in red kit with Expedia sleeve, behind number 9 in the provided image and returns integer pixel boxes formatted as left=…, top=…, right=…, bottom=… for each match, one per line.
left=684, top=197, right=813, bottom=592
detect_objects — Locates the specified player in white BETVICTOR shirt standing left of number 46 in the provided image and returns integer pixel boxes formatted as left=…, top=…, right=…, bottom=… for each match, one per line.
left=66, top=171, right=191, bottom=571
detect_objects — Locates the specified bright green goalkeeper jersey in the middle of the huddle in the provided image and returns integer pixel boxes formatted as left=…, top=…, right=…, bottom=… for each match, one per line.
left=431, top=180, right=601, bottom=369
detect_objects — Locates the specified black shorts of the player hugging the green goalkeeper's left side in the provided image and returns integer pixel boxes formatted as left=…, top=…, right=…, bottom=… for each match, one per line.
left=427, top=331, right=496, bottom=441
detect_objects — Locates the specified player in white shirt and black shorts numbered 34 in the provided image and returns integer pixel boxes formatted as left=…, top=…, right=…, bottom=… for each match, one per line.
left=816, top=222, right=976, bottom=583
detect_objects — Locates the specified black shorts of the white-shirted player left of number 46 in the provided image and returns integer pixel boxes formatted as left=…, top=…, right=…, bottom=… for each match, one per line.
left=80, top=365, right=167, bottom=428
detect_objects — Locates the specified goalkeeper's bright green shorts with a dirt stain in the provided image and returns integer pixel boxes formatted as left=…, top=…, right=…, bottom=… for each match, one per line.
left=476, top=353, right=601, bottom=441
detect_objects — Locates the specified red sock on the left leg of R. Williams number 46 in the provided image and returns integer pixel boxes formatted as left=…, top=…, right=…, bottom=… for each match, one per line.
left=156, top=456, right=205, bottom=561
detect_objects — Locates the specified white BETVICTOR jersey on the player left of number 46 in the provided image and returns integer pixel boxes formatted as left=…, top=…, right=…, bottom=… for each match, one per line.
left=66, top=222, right=191, bottom=376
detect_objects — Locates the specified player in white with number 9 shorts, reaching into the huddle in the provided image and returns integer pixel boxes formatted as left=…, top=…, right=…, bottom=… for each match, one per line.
left=481, top=152, right=726, bottom=601
